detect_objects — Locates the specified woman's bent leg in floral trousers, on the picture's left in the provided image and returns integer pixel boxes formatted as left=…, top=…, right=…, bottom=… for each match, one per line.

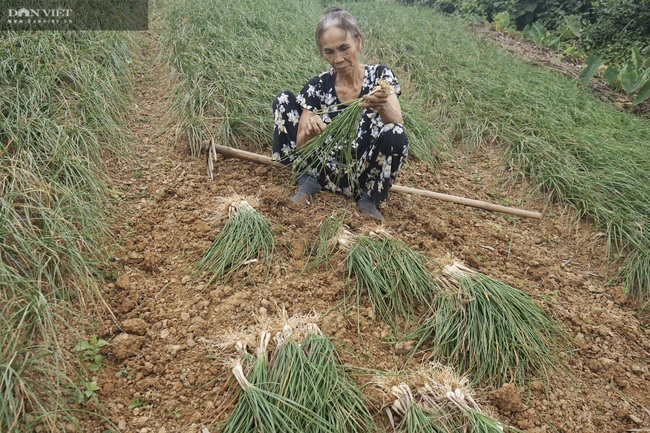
left=272, top=90, right=302, bottom=165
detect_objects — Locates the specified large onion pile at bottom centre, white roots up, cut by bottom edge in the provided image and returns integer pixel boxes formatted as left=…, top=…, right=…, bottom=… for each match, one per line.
left=216, top=324, right=377, bottom=433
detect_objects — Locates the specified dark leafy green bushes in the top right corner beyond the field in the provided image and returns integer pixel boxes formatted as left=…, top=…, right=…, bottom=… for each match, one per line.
left=399, top=0, right=650, bottom=105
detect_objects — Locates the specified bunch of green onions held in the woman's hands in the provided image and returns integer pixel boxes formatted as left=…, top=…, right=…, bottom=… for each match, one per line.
left=293, top=81, right=392, bottom=190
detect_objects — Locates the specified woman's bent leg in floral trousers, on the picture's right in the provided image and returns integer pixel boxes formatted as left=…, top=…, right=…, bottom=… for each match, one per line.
left=358, top=123, right=408, bottom=215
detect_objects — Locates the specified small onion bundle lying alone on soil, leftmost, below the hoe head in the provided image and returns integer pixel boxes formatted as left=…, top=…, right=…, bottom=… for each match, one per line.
left=194, top=201, right=275, bottom=283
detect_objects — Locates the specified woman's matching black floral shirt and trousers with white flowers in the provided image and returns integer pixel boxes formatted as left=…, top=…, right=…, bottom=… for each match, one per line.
left=272, top=65, right=408, bottom=203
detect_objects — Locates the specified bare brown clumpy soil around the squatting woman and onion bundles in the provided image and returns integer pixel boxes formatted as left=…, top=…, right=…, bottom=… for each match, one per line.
left=88, top=32, right=650, bottom=433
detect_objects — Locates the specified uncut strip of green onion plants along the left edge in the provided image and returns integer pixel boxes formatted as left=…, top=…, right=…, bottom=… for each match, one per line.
left=0, top=31, right=136, bottom=432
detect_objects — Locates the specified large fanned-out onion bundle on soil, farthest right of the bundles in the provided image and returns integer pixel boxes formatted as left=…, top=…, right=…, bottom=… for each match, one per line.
left=409, top=263, right=568, bottom=386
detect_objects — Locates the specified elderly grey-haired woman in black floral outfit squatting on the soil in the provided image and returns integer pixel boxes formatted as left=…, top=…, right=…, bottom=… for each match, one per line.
left=273, top=8, right=408, bottom=220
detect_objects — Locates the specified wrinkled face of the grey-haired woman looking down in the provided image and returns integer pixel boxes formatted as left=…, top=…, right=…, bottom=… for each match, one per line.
left=320, top=27, right=361, bottom=75
